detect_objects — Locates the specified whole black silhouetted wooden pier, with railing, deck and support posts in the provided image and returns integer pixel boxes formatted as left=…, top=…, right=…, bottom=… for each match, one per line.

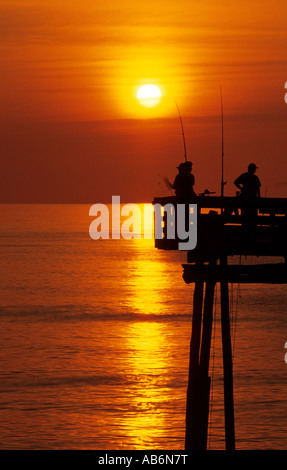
left=153, top=196, right=287, bottom=450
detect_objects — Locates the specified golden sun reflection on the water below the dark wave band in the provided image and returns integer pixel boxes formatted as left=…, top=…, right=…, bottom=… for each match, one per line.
left=126, top=322, right=173, bottom=449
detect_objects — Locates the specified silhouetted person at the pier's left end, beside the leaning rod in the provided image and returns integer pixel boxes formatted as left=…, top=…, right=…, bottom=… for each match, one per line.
left=172, top=161, right=196, bottom=203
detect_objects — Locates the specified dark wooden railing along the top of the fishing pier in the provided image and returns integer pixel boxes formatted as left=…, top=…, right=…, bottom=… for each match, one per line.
left=153, top=196, right=287, bottom=262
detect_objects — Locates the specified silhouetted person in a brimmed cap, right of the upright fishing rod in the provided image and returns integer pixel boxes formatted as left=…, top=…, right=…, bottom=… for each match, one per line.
left=234, top=163, right=261, bottom=222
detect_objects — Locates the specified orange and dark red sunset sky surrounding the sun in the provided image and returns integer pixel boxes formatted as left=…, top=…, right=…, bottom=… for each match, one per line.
left=0, top=0, right=287, bottom=203
